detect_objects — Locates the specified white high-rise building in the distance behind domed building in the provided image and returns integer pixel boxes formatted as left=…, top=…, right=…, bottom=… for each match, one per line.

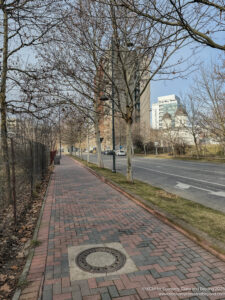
left=152, top=94, right=181, bottom=129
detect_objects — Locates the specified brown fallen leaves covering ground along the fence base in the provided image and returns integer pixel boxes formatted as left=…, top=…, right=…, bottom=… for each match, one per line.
left=0, top=172, right=50, bottom=300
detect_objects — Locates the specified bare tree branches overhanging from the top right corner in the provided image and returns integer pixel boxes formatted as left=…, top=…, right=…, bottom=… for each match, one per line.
left=120, top=0, right=225, bottom=50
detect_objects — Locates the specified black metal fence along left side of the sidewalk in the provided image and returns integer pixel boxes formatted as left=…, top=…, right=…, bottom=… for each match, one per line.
left=0, top=136, right=50, bottom=222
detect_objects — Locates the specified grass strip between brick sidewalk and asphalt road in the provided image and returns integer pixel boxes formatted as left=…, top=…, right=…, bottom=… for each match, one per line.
left=73, top=157, right=225, bottom=251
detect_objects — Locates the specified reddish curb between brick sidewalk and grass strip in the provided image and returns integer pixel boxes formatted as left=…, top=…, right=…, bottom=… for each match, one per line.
left=71, top=159, right=225, bottom=262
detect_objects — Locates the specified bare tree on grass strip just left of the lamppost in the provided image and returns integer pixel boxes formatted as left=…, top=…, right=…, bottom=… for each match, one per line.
left=35, top=1, right=110, bottom=167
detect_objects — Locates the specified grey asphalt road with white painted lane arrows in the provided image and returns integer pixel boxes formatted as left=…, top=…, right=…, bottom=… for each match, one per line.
left=78, top=154, right=225, bottom=212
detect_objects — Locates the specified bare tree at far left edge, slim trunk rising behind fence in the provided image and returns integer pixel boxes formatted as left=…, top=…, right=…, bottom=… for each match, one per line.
left=0, top=0, right=63, bottom=201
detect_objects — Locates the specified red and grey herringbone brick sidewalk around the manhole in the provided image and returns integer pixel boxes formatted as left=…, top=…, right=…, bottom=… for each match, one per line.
left=20, top=157, right=225, bottom=300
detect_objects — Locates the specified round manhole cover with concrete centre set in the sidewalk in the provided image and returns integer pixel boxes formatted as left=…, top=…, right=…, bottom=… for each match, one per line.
left=76, top=247, right=126, bottom=273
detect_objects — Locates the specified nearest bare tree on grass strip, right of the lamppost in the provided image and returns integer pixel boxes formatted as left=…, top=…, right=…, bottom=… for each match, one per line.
left=96, top=1, right=192, bottom=181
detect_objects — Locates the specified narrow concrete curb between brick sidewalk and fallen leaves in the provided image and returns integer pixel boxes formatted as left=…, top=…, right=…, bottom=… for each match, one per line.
left=12, top=173, right=53, bottom=300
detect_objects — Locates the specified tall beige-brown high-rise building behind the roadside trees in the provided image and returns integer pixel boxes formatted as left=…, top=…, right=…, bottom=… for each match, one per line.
left=96, top=51, right=150, bottom=150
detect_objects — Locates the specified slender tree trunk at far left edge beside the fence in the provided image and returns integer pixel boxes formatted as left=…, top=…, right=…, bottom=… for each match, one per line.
left=0, top=11, right=12, bottom=203
